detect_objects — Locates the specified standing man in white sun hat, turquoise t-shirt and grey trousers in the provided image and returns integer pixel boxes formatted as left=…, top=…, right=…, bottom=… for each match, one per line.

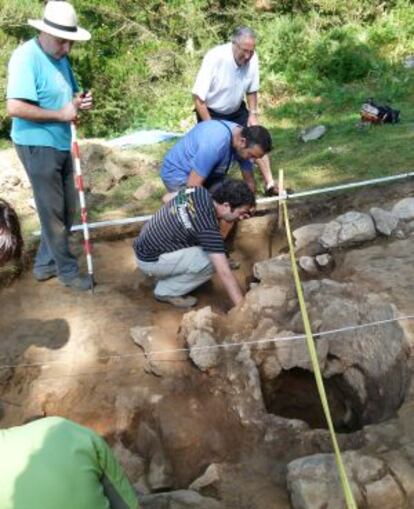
left=7, top=0, right=92, bottom=291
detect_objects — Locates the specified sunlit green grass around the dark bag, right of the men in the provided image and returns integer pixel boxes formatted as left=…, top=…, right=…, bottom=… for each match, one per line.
left=267, top=77, right=414, bottom=191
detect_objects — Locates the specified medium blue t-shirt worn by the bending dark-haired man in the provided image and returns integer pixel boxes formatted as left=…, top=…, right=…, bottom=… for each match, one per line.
left=161, top=120, right=253, bottom=190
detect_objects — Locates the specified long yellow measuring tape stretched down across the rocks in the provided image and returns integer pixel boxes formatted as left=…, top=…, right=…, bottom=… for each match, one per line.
left=282, top=200, right=358, bottom=509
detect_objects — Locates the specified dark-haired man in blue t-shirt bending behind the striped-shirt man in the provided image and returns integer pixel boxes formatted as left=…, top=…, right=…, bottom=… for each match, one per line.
left=161, top=120, right=272, bottom=202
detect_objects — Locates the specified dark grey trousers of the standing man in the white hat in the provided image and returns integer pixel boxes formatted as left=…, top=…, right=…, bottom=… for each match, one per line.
left=16, top=145, right=79, bottom=282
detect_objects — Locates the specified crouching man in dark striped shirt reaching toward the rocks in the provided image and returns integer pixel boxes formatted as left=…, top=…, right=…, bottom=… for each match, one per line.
left=134, top=179, right=255, bottom=308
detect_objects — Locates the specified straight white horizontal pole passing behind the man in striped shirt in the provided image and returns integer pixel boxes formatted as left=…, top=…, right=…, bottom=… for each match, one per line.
left=33, top=172, right=414, bottom=236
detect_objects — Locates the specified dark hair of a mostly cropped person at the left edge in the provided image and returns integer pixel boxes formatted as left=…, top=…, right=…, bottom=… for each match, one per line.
left=0, top=198, right=23, bottom=265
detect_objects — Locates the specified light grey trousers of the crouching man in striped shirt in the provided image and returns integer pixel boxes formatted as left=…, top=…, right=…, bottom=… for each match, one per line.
left=137, top=246, right=214, bottom=297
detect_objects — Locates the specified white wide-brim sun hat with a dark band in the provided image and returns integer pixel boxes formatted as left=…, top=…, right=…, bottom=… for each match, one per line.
left=27, top=0, right=91, bottom=41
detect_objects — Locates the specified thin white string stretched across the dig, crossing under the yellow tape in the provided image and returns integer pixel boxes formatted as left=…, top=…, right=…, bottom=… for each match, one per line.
left=0, top=315, right=414, bottom=369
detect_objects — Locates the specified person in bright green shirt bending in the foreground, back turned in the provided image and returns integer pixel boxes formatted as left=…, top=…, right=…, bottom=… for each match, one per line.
left=0, top=417, right=138, bottom=509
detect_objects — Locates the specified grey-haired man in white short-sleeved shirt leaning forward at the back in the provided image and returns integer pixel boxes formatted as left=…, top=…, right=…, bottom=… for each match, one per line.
left=192, top=27, right=275, bottom=195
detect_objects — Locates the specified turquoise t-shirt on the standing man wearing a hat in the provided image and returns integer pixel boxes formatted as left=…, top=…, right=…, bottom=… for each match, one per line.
left=7, top=39, right=78, bottom=150
